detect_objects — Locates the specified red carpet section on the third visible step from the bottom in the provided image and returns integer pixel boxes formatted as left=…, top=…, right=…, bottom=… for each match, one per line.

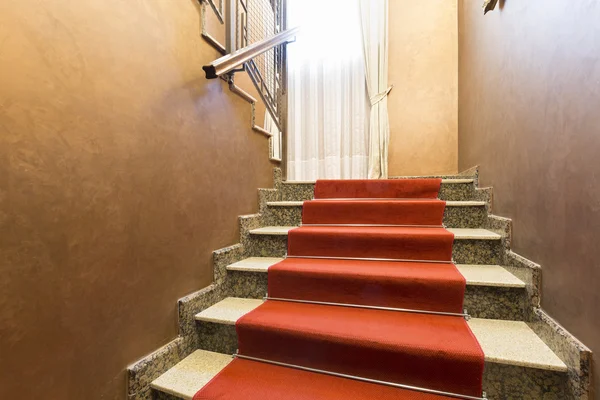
left=268, top=258, right=465, bottom=313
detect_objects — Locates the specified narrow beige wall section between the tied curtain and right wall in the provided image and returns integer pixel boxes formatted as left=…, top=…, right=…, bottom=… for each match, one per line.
left=388, top=0, right=458, bottom=176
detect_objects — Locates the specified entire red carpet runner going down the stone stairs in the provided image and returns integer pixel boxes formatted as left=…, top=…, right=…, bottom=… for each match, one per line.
left=194, top=179, right=484, bottom=400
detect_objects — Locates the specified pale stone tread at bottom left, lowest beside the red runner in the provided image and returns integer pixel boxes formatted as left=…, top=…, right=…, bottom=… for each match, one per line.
left=150, top=350, right=233, bottom=400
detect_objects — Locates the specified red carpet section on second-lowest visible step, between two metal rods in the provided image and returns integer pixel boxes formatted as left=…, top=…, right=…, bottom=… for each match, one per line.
left=237, top=301, right=483, bottom=396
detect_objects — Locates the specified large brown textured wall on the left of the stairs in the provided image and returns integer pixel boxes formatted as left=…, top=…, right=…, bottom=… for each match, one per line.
left=0, top=0, right=272, bottom=400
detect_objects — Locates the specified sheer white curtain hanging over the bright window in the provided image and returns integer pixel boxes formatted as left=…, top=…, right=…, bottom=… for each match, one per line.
left=287, top=0, right=370, bottom=180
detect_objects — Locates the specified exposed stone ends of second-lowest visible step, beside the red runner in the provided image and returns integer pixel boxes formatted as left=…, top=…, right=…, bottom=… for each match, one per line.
left=186, top=298, right=568, bottom=400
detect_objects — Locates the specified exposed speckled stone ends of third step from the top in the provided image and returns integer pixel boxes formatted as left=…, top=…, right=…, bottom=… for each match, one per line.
left=243, top=226, right=503, bottom=265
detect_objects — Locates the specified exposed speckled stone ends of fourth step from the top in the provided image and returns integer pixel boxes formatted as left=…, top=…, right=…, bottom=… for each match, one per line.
left=227, top=257, right=528, bottom=320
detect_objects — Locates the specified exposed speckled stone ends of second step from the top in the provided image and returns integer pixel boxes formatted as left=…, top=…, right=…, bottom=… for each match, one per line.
left=265, top=201, right=487, bottom=228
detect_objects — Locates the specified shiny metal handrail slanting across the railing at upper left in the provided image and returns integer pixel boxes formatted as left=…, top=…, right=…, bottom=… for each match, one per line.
left=202, top=27, right=300, bottom=79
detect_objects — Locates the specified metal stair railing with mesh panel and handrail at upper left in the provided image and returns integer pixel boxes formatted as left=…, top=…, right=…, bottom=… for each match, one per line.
left=202, top=0, right=299, bottom=170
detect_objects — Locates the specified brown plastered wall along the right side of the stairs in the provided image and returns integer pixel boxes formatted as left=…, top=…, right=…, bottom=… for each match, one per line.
left=459, top=0, right=600, bottom=394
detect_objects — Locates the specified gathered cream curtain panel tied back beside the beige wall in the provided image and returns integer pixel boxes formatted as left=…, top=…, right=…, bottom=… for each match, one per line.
left=359, top=0, right=391, bottom=179
